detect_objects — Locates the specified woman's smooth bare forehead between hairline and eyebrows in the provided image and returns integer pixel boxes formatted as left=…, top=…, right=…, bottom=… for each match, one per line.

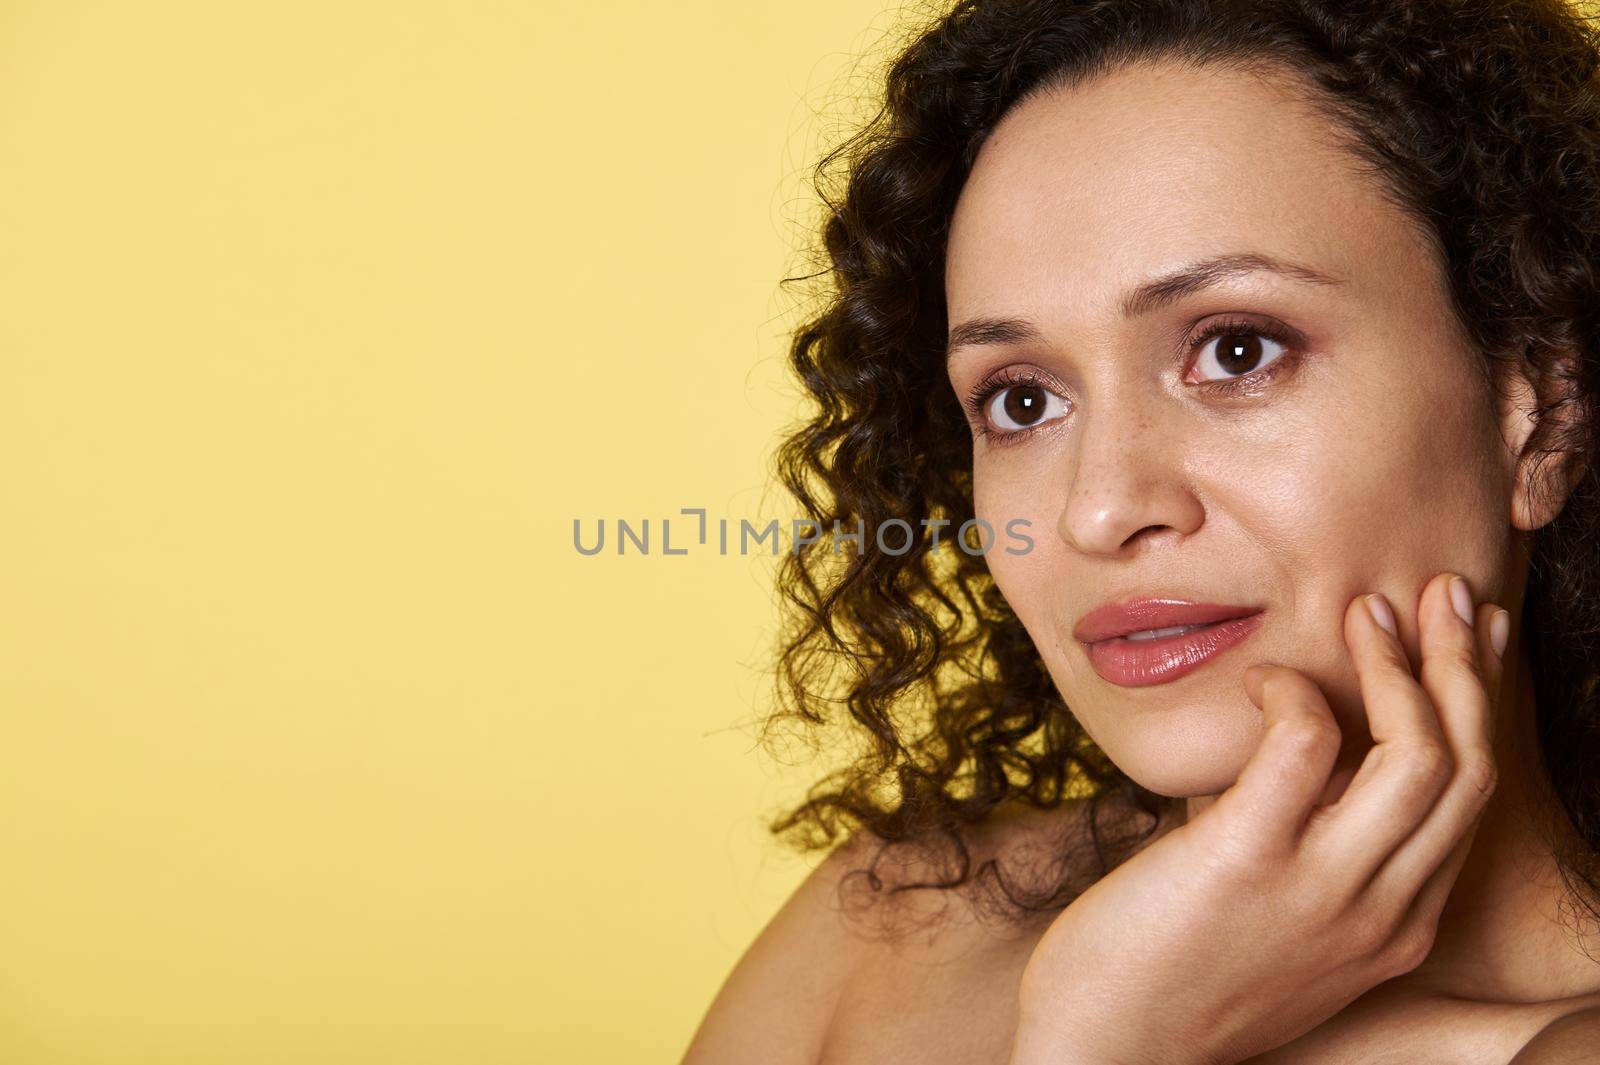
left=946, top=61, right=1421, bottom=320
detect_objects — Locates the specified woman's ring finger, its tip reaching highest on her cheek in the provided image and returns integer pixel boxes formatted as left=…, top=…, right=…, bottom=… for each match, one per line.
left=1370, top=574, right=1499, bottom=905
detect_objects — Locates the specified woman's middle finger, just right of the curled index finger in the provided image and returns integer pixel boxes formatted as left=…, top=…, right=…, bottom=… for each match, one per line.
left=1306, top=590, right=1459, bottom=891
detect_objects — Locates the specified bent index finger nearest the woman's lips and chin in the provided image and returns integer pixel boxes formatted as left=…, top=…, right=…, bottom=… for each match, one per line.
left=1206, top=664, right=1344, bottom=849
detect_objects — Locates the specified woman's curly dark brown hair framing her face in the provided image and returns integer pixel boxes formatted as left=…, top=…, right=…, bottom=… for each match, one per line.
left=763, top=0, right=1600, bottom=916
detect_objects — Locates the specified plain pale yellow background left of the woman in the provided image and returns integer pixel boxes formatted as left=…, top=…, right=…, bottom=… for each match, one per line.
left=0, top=0, right=899, bottom=1065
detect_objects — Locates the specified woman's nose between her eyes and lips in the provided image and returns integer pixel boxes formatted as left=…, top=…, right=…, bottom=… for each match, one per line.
left=1058, top=413, right=1205, bottom=558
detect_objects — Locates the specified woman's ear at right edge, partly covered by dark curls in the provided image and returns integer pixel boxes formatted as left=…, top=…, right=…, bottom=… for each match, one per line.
left=1494, top=345, right=1589, bottom=533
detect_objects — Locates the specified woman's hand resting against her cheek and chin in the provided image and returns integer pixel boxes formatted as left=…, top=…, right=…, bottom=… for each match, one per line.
left=1011, top=574, right=1501, bottom=1065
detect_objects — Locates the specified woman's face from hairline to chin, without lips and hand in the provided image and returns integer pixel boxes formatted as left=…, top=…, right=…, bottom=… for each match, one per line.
left=946, top=57, right=1525, bottom=796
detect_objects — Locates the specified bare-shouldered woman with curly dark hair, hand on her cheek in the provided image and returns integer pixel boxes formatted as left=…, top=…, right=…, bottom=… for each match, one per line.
left=686, top=0, right=1600, bottom=1065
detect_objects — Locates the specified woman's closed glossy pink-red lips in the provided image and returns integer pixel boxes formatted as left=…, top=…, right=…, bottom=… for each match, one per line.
left=1074, top=600, right=1261, bottom=688
